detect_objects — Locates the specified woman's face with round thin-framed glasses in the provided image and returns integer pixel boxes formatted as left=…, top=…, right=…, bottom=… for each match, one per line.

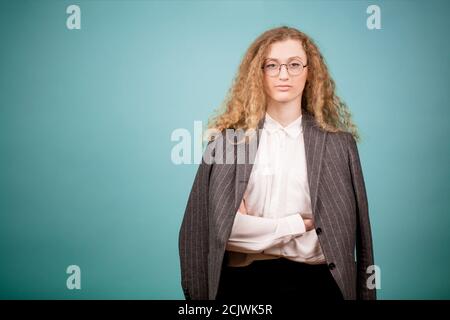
left=263, top=39, right=308, bottom=103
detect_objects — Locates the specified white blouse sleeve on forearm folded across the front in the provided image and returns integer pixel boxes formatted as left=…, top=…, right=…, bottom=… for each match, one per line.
left=226, top=211, right=306, bottom=253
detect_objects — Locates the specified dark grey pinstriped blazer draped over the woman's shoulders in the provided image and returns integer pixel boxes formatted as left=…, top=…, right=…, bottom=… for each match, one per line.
left=178, top=110, right=376, bottom=300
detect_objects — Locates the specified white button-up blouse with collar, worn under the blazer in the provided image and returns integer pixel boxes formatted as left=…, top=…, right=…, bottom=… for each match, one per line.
left=226, top=112, right=326, bottom=266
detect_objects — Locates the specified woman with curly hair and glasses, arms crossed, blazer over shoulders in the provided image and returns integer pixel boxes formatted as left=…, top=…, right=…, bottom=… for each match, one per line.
left=179, top=26, right=376, bottom=300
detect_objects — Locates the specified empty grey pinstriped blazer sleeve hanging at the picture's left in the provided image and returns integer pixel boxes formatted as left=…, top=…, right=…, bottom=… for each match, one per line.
left=178, top=141, right=213, bottom=300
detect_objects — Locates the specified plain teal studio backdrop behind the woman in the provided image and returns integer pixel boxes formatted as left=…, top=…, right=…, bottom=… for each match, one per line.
left=0, top=1, right=450, bottom=299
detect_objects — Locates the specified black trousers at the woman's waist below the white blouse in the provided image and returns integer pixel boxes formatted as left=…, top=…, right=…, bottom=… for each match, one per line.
left=216, top=258, right=343, bottom=302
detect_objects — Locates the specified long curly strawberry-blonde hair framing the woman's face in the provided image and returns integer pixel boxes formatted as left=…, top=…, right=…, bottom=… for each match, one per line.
left=205, top=26, right=359, bottom=141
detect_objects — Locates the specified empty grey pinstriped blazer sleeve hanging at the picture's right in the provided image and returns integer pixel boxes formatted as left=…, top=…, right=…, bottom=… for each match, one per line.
left=348, top=134, right=376, bottom=300
